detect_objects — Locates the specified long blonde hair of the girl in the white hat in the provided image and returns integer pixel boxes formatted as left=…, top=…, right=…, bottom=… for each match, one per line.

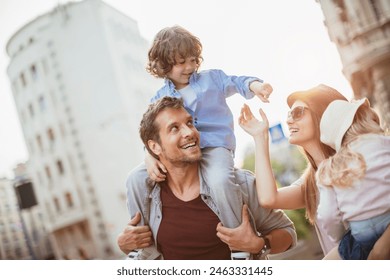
left=316, top=105, right=384, bottom=187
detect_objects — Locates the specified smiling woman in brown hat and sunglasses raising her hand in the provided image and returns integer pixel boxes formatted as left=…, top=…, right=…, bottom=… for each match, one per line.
left=235, top=85, right=390, bottom=259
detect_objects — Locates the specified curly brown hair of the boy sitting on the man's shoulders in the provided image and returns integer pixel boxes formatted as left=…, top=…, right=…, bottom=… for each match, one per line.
left=146, top=25, right=203, bottom=78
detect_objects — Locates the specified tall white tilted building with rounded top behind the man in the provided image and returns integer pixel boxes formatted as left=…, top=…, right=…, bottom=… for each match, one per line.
left=6, top=0, right=159, bottom=259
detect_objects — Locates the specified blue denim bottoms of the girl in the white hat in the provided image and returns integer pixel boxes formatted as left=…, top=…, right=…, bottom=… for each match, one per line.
left=339, top=212, right=390, bottom=260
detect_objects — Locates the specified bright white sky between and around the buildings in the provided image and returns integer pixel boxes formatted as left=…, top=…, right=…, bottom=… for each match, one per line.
left=0, top=0, right=352, bottom=178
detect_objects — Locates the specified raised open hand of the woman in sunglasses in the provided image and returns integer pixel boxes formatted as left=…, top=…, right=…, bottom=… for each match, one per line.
left=238, top=104, right=269, bottom=137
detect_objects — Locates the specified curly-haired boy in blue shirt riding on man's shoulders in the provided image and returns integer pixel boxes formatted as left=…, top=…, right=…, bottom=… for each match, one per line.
left=127, top=26, right=272, bottom=259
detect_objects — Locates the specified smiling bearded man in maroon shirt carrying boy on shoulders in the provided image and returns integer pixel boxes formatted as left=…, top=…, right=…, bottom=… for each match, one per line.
left=118, top=97, right=296, bottom=260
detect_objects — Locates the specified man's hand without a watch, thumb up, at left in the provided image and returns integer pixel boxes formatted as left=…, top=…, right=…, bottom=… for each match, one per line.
left=117, top=212, right=153, bottom=255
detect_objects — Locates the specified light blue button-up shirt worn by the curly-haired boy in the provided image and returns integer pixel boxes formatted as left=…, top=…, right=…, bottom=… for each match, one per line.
left=151, top=69, right=263, bottom=151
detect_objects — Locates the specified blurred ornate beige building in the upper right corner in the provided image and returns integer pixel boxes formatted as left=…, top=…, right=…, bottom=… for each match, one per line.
left=317, top=0, right=390, bottom=128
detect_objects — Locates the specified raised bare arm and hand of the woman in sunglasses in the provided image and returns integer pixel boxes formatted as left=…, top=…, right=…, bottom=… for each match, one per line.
left=239, top=104, right=305, bottom=209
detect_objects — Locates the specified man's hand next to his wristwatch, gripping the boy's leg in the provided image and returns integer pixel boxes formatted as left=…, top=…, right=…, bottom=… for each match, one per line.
left=217, top=205, right=264, bottom=254
